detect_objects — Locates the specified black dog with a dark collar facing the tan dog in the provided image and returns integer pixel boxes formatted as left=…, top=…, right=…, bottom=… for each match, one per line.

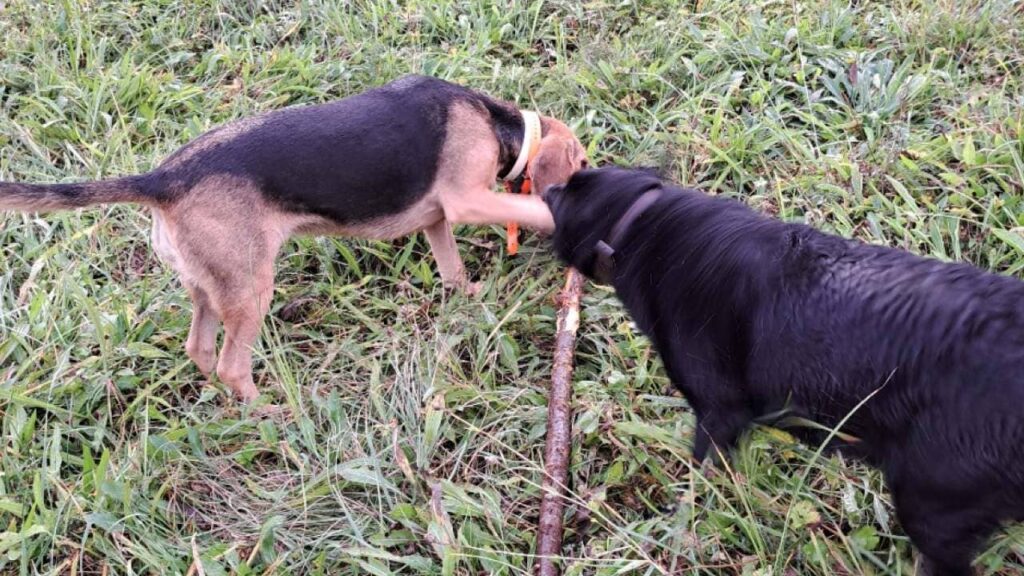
left=545, top=168, right=1024, bottom=576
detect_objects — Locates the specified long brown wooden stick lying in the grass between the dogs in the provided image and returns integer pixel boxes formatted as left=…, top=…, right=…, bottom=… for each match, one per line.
left=537, top=269, right=583, bottom=576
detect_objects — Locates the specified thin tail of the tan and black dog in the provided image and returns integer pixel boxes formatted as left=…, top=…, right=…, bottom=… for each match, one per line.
left=0, top=175, right=155, bottom=212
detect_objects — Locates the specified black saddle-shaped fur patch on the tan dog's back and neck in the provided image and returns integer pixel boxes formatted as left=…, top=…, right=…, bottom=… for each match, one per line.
left=151, top=76, right=522, bottom=219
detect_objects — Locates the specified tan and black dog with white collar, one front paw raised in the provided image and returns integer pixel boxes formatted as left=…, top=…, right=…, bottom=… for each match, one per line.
left=0, top=76, right=587, bottom=401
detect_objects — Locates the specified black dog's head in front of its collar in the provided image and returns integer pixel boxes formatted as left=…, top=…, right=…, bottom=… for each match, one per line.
left=544, top=163, right=662, bottom=279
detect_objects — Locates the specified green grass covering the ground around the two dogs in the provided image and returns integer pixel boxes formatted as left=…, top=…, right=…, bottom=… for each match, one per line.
left=0, top=0, right=1024, bottom=576
